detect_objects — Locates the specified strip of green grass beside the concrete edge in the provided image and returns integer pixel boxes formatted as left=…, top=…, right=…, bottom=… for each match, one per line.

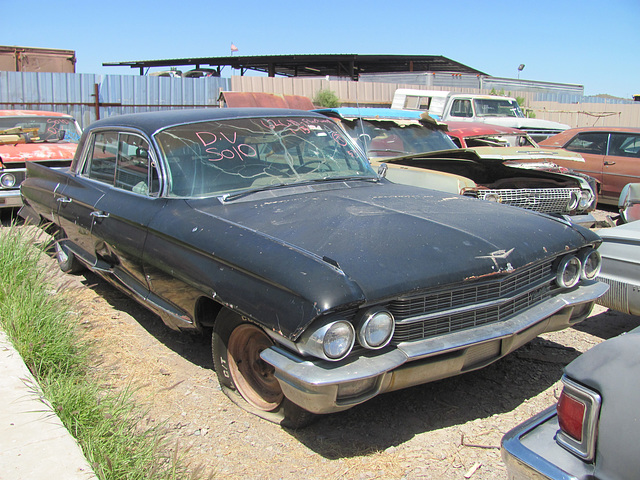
left=0, top=226, right=206, bottom=480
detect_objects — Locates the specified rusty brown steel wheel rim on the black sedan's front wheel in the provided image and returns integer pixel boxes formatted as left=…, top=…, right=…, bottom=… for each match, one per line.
left=227, top=323, right=284, bottom=412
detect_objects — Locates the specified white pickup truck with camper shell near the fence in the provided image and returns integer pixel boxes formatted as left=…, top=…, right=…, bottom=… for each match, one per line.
left=391, top=88, right=569, bottom=142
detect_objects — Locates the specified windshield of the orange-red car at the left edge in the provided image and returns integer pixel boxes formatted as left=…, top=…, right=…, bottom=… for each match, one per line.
left=0, top=115, right=80, bottom=143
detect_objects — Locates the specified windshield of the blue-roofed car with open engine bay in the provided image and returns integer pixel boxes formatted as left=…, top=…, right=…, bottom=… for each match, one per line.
left=342, top=120, right=457, bottom=158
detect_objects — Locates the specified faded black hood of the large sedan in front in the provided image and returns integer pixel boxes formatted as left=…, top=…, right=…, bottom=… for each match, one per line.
left=189, top=180, right=599, bottom=308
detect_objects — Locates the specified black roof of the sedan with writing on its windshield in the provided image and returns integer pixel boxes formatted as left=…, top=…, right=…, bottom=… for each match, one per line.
left=85, top=107, right=327, bottom=136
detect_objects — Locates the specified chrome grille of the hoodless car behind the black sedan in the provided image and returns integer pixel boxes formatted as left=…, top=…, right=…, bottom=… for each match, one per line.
left=477, top=188, right=580, bottom=213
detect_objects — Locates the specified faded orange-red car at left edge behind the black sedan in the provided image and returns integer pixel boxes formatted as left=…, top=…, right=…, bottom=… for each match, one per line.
left=0, top=110, right=82, bottom=208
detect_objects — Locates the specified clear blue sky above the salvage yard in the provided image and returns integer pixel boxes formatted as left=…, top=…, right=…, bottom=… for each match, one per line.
left=0, top=0, right=640, bottom=98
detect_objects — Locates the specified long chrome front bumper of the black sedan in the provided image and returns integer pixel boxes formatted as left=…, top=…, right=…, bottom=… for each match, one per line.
left=260, top=282, right=608, bottom=413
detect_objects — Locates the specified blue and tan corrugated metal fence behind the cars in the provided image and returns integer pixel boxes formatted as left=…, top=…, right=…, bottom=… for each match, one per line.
left=0, top=72, right=640, bottom=127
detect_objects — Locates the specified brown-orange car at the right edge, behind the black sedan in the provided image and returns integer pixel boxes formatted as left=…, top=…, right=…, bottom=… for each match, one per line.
left=540, top=127, right=640, bottom=205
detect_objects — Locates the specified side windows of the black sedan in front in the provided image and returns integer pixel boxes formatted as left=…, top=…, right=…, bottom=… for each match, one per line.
left=82, top=132, right=160, bottom=195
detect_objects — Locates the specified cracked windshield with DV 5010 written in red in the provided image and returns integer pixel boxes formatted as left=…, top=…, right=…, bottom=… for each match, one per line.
left=156, top=117, right=377, bottom=197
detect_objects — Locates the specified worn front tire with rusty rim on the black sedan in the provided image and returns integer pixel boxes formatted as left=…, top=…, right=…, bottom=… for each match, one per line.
left=211, top=309, right=315, bottom=428
